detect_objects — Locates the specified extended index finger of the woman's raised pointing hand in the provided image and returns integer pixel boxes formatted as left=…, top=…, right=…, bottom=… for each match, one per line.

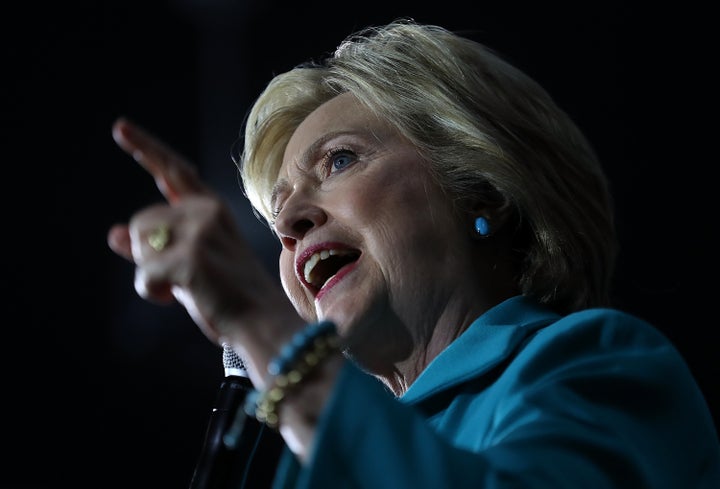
left=112, top=118, right=208, bottom=204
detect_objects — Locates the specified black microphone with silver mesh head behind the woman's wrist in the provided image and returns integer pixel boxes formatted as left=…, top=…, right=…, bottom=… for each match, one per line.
left=190, top=344, right=276, bottom=489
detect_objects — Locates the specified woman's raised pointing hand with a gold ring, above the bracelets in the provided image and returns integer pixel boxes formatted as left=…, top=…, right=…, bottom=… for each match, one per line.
left=107, top=119, right=302, bottom=380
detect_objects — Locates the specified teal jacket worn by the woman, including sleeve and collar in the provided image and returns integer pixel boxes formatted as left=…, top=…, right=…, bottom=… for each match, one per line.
left=273, top=296, right=720, bottom=489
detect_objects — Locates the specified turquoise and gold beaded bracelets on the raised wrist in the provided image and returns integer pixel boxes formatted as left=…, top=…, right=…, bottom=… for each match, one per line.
left=245, top=321, right=340, bottom=428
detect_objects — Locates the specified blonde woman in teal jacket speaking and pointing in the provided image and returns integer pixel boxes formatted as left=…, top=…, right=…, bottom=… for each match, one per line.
left=108, top=20, right=720, bottom=488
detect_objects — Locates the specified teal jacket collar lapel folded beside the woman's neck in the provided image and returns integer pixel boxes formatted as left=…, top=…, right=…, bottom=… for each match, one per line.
left=400, top=295, right=560, bottom=403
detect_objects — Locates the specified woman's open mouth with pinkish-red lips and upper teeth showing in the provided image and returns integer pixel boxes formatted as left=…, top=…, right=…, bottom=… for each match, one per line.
left=296, top=243, right=360, bottom=294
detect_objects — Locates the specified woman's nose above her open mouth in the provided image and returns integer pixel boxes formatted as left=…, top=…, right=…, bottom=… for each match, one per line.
left=275, top=189, right=327, bottom=251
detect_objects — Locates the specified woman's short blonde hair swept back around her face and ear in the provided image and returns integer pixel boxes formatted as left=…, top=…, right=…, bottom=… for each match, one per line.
left=238, top=19, right=617, bottom=312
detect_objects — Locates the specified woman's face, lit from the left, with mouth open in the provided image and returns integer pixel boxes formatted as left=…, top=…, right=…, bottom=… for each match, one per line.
left=272, top=94, right=471, bottom=366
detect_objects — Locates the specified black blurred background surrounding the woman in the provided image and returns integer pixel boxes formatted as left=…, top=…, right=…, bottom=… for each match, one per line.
left=0, top=0, right=720, bottom=489
